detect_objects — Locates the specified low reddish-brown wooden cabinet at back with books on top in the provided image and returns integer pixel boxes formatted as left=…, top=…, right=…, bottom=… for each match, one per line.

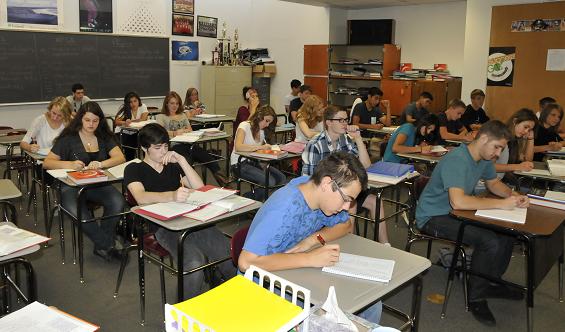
left=381, top=78, right=461, bottom=115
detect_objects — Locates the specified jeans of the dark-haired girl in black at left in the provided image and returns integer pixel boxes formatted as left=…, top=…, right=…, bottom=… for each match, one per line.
left=61, top=184, right=125, bottom=250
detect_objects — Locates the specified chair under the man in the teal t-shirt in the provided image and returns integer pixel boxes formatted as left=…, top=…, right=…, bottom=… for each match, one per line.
left=405, top=176, right=469, bottom=318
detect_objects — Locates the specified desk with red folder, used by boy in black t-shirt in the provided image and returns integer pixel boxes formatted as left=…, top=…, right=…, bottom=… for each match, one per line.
left=131, top=202, right=263, bottom=325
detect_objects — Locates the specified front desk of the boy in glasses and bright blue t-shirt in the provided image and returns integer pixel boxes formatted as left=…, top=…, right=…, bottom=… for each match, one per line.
left=275, top=234, right=431, bottom=331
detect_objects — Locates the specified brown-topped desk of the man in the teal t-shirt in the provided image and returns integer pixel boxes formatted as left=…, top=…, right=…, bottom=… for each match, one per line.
left=447, top=205, right=565, bottom=331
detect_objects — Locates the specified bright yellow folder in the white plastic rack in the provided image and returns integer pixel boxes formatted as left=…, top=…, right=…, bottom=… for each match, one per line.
left=165, top=275, right=303, bottom=332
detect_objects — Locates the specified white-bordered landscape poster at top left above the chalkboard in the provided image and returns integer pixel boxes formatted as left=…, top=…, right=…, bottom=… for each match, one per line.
left=6, top=0, right=63, bottom=30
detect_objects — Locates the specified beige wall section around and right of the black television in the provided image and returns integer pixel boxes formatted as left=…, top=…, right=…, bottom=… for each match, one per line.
left=344, top=1, right=466, bottom=76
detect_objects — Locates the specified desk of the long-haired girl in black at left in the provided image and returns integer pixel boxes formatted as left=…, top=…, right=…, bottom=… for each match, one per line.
left=48, top=170, right=129, bottom=283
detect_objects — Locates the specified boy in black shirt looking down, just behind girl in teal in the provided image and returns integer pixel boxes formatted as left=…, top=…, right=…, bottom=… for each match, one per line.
left=438, top=99, right=473, bottom=142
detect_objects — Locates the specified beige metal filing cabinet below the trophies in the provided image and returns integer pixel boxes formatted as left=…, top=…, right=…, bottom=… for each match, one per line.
left=200, top=66, right=251, bottom=116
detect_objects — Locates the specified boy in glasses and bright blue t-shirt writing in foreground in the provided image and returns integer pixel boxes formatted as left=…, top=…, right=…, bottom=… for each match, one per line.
left=238, top=152, right=382, bottom=323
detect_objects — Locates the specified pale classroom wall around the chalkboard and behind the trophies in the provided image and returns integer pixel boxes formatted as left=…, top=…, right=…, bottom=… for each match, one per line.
left=0, top=0, right=330, bottom=128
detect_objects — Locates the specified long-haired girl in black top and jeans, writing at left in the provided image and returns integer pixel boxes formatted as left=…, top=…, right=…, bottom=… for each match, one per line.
left=43, top=101, right=126, bottom=261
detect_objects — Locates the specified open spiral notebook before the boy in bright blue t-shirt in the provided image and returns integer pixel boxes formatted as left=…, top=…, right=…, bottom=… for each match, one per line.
left=322, top=252, right=394, bottom=282
